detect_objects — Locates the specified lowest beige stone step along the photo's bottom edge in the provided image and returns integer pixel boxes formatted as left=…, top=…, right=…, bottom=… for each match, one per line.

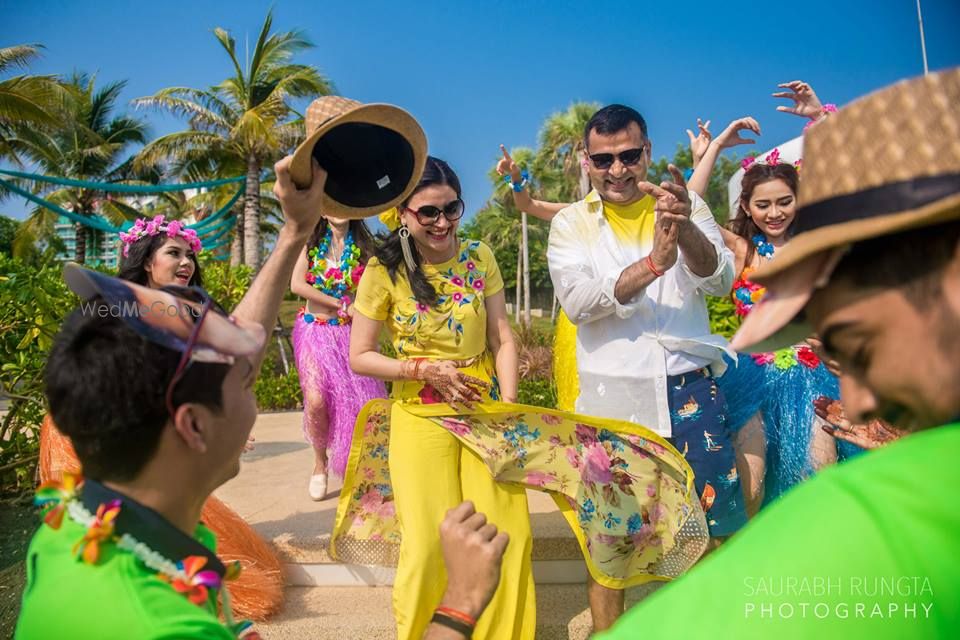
left=256, top=584, right=659, bottom=640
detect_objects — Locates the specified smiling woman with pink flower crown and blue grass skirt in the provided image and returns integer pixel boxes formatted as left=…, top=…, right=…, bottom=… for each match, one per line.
left=689, top=81, right=858, bottom=514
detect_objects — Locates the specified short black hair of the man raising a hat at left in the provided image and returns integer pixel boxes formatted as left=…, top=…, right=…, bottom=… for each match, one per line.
left=44, top=298, right=230, bottom=482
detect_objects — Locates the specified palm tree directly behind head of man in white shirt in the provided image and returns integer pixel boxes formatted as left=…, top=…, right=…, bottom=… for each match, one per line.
left=536, top=102, right=600, bottom=202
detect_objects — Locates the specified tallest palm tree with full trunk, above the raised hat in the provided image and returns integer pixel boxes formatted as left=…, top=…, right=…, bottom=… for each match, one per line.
left=136, top=11, right=333, bottom=269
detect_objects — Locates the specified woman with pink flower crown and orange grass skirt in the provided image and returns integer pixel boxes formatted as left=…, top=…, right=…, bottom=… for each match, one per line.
left=39, top=215, right=283, bottom=620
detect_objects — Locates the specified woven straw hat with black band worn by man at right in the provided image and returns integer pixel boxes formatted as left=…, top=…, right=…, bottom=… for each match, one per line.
left=733, top=67, right=960, bottom=351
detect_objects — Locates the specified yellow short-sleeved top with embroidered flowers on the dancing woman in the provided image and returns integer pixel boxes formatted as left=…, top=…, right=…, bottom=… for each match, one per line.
left=354, top=240, right=503, bottom=360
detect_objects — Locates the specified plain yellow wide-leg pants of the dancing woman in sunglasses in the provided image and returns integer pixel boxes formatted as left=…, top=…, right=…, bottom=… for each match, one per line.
left=389, top=403, right=537, bottom=640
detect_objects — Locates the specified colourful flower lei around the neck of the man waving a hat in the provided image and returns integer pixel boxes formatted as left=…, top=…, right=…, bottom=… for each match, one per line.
left=34, top=473, right=260, bottom=640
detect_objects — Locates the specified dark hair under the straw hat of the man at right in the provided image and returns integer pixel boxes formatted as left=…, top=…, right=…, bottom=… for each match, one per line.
left=831, top=220, right=960, bottom=309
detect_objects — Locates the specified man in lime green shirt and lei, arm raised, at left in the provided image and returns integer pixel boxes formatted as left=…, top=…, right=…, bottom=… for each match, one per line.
left=16, top=160, right=334, bottom=640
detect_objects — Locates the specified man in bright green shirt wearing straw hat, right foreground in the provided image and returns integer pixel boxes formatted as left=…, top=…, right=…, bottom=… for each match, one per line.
left=597, top=69, right=960, bottom=640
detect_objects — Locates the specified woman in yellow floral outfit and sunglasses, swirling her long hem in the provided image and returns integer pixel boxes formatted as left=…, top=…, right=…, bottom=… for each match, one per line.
left=342, top=158, right=707, bottom=640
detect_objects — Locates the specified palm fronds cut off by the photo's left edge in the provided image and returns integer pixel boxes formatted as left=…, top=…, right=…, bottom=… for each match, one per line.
left=0, top=44, right=63, bottom=164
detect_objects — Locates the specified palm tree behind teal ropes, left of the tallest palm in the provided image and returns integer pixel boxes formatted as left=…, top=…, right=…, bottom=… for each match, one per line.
left=15, top=73, right=147, bottom=263
